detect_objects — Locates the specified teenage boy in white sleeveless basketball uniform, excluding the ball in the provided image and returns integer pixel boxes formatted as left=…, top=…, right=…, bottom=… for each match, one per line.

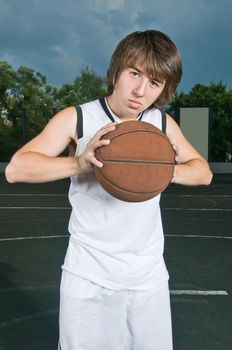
left=6, top=30, right=212, bottom=350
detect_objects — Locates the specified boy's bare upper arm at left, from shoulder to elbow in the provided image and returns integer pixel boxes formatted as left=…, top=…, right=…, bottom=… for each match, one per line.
left=16, top=107, right=77, bottom=157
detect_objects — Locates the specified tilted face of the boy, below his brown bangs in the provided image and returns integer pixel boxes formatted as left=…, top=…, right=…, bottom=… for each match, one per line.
left=108, top=66, right=165, bottom=119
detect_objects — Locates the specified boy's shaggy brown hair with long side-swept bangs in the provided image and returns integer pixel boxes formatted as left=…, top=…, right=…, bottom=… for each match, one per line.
left=107, top=30, right=182, bottom=108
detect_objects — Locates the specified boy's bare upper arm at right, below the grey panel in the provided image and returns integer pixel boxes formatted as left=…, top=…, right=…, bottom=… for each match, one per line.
left=166, top=115, right=205, bottom=163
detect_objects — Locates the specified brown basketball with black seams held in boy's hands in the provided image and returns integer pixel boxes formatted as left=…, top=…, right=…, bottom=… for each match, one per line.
left=94, top=121, right=175, bottom=202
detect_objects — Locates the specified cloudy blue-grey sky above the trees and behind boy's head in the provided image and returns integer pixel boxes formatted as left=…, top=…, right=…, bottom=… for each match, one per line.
left=0, top=0, right=232, bottom=92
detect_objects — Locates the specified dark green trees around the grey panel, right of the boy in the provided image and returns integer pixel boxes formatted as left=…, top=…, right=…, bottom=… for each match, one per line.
left=170, top=82, right=232, bottom=162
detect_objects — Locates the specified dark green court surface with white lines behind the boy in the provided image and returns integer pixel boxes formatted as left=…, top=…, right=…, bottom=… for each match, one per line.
left=0, top=176, right=232, bottom=350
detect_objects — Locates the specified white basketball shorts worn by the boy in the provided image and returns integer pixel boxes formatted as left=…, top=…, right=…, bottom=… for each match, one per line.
left=59, top=271, right=172, bottom=350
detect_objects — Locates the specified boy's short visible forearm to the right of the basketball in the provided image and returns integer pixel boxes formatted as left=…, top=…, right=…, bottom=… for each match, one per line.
left=172, top=159, right=212, bottom=186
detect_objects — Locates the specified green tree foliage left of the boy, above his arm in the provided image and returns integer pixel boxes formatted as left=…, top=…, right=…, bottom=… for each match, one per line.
left=0, top=61, right=106, bottom=161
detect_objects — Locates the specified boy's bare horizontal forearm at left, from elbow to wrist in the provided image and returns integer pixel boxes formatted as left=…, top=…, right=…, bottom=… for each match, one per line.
left=6, top=152, right=79, bottom=183
